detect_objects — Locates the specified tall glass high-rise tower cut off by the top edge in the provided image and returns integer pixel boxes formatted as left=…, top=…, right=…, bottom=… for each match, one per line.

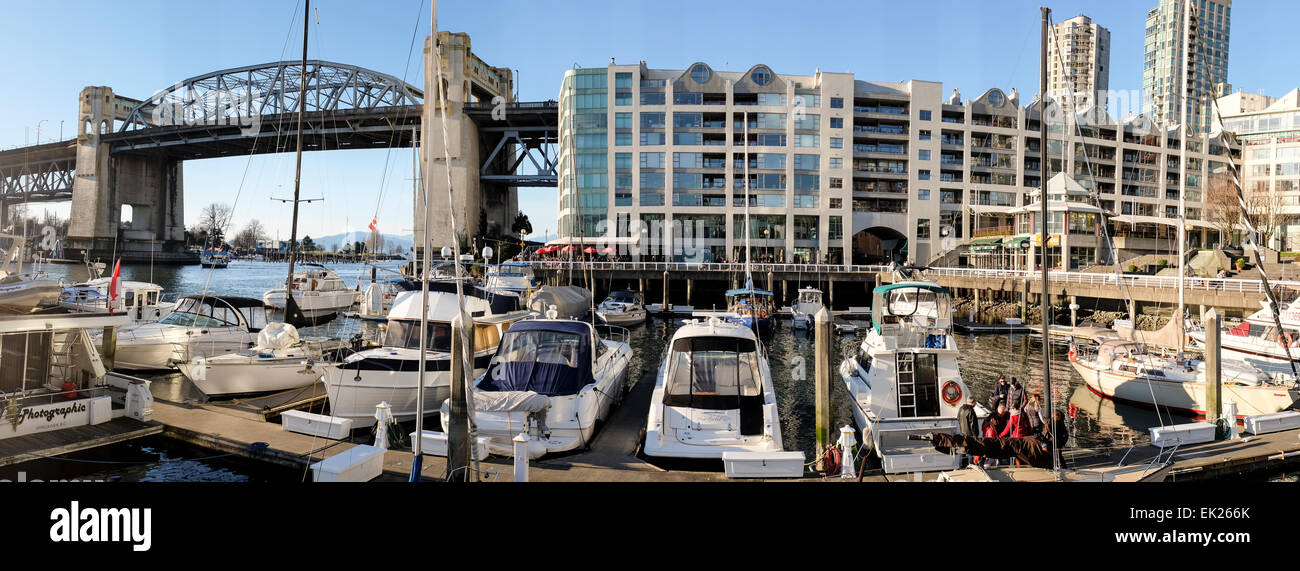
left=1141, top=0, right=1232, bottom=131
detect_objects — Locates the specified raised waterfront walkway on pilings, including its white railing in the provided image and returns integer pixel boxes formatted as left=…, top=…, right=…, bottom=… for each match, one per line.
left=520, top=260, right=1300, bottom=315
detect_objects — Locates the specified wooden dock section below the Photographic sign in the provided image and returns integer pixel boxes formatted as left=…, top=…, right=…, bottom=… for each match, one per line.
left=0, top=416, right=164, bottom=466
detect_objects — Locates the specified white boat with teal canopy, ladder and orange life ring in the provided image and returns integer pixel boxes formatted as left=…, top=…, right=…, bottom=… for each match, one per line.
left=840, top=280, right=988, bottom=473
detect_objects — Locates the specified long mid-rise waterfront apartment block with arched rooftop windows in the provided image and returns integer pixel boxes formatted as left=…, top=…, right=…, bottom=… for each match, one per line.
left=559, top=62, right=1229, bottom=268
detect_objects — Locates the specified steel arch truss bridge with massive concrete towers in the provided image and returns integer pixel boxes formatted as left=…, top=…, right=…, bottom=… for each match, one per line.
left=0, top=31, right=559, bottom=264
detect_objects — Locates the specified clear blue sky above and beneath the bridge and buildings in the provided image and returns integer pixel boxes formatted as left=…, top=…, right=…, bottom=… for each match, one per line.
left=0, top=0, right=1300, bottom=237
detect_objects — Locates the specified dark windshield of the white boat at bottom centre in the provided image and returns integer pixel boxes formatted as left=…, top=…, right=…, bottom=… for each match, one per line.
left=663, top=337, right=763, bottom=410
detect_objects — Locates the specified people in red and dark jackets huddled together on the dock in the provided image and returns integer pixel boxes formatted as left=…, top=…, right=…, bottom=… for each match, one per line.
left=957, top=375, right=1069, bottom=466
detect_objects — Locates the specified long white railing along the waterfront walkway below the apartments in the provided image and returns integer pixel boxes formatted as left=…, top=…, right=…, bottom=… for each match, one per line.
left=529, top=260, right=1300, bottom=294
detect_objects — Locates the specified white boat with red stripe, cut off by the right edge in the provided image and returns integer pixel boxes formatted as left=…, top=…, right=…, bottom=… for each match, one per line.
left=1187, top=303, right=1300, bottom=377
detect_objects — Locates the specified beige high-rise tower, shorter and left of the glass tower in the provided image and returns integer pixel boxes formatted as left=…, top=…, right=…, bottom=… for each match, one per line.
left=1048, top=14, right=1110, bottom=108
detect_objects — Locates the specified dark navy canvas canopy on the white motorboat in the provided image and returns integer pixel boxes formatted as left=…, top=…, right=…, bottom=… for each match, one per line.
left=478, top=320, right=595, bottom=397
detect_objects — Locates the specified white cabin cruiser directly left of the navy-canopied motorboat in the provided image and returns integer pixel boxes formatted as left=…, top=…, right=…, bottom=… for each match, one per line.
left=324, top=281, right=532, bottom=427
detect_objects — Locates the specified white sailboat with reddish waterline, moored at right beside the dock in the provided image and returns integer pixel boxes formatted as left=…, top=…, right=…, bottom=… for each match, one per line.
left=1070, top=336, right=1300, bottom=418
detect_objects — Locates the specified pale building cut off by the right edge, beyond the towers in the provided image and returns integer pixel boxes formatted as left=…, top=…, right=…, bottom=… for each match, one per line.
left=1218, top=90, right=1300, bottom=251
